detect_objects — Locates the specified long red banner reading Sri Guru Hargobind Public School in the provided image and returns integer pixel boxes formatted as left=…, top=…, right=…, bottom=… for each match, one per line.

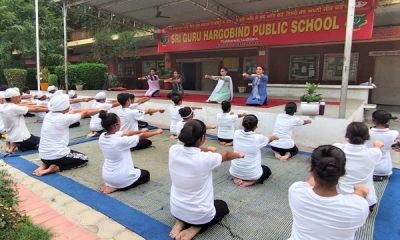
left=158, top=0, right=374, bottom=52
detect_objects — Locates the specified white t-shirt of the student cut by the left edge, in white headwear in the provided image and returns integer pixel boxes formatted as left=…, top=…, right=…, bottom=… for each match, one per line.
left=0, top=103, right=31, bottom=142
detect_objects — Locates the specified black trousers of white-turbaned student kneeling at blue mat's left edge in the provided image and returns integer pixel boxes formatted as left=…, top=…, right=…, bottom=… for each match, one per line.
left=42, top=150, right=89, bottom=171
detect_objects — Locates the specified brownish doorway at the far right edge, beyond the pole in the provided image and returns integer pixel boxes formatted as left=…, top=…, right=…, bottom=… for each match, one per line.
left=371, top=56, right=400, bottom=106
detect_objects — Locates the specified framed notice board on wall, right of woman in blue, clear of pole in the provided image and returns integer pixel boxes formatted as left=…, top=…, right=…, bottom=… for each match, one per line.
left=289, top=55, right=319, bottom=81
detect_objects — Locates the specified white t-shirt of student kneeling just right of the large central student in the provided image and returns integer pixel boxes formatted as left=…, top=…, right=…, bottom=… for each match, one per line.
left=229, top=130, right=269, bottom=180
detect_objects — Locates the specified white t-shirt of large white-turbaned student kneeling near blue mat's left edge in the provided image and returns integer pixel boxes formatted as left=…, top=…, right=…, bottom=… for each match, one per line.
left=39, top=112, right=81, bottom=160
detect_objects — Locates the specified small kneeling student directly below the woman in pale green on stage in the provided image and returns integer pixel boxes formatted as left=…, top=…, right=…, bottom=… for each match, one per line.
left=217, top=101, right=246, bottom=146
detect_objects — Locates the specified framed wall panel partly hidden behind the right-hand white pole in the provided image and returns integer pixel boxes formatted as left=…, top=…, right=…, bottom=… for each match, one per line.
left=322, top=53, right=358, bottom=81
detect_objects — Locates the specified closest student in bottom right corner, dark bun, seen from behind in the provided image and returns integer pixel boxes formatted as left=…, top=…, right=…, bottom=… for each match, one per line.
left=288, top=145, right=369, bottom=240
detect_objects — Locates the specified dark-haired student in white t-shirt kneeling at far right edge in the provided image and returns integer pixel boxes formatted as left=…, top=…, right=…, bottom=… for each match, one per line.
left=367, top=110, right=399, bottom=181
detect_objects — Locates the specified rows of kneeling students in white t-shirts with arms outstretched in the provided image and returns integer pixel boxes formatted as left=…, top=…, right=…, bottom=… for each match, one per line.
left=0, top=84, right=399, bottom=239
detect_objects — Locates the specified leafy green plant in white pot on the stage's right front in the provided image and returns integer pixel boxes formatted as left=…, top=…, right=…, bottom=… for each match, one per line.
left=300, top=82, right=322, bottom=116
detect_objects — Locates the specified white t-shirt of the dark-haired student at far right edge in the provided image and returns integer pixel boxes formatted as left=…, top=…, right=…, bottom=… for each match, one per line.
left=367, top=128, right=399, bottom=176
